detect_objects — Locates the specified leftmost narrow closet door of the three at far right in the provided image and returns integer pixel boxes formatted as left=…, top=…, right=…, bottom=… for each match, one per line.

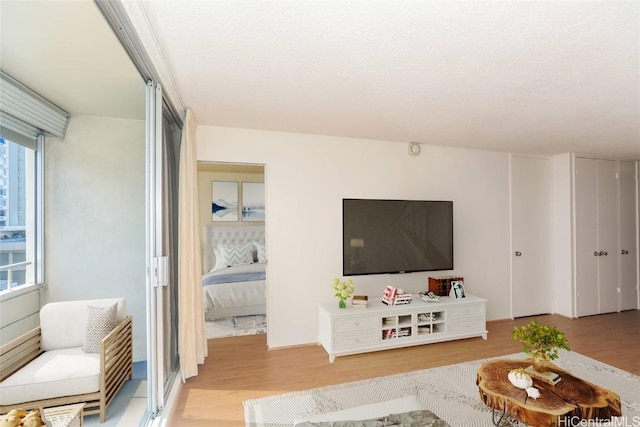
left=574, top=158, right=598, bottom=317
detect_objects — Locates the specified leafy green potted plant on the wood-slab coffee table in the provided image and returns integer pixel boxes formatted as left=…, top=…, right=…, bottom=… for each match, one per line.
left=511, top=320, right=570, bottom=373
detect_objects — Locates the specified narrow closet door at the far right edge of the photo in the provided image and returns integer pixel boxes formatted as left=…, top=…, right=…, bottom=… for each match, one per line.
left=618, top=162, right=639, bottom=310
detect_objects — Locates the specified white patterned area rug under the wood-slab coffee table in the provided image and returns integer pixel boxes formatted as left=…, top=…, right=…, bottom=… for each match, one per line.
left=243, top=351, right=640, bottom=427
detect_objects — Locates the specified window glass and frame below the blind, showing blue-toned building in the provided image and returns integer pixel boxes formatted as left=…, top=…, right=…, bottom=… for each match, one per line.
left=0, top=137, right=41, bottom=292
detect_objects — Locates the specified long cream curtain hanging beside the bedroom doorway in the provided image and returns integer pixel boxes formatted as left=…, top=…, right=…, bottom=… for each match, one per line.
left=178, top=110, right=208, bottom=382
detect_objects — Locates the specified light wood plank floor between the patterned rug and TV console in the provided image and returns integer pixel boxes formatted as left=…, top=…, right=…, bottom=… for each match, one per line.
left=169, top=310, right=640, bottom=427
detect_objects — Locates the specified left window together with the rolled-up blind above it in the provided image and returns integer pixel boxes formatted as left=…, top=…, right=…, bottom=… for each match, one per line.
left=0, top=70, right=61, bottom=293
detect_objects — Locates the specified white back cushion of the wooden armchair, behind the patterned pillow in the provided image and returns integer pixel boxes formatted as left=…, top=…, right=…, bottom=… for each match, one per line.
left=40, top=298, right=127, bottom=351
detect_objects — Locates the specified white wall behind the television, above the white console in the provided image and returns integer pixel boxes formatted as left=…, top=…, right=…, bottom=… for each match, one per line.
left=197, top=126, right=510, bottom=348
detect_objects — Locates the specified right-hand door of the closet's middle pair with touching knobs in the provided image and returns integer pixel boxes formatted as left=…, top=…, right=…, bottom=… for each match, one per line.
left=597, top=160, right=620, bottom=313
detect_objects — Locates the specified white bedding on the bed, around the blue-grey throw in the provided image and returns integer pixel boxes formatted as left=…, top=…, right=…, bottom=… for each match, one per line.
left=202, top=263, right=267, bottom=320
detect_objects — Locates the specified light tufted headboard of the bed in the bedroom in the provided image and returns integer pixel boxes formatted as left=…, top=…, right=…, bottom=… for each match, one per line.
left=202, top=225, right=265, bottom=273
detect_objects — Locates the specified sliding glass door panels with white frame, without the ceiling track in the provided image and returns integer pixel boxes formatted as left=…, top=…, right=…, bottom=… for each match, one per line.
left=146, top=81, right=180, bottom=419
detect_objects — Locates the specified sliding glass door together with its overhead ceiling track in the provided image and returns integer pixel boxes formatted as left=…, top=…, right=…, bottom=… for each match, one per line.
left=94, top=0, right=184, bottom=424
